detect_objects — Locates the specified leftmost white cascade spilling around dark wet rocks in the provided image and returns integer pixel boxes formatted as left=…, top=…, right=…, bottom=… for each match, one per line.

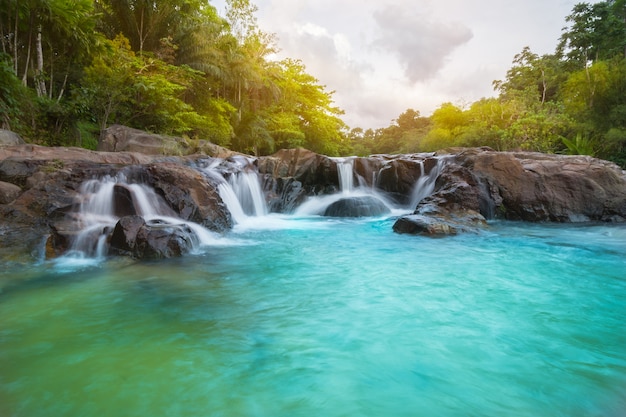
left=58, top=173, right=227, bottom=258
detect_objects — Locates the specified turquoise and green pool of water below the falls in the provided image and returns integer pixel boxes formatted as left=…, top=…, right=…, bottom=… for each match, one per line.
left=0, top=218, right=626, bottom=417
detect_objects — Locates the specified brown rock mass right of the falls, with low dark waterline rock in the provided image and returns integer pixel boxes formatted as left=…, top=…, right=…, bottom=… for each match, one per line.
left=394, top=148, right=626, bottom=235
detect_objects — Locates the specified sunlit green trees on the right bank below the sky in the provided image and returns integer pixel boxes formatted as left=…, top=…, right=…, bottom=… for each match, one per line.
left=349, top=0, right=626, bottom=168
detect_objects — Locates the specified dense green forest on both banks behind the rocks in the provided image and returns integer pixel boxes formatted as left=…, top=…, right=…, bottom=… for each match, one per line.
left=0, top=0, right=626, bottom=166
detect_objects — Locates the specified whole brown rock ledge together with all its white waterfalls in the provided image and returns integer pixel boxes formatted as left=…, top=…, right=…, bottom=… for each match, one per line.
left=0, top=132, right=626, bottom=259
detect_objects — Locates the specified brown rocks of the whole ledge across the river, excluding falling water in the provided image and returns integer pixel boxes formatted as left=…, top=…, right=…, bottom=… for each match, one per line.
left=0, top=127, right=626, bottom=258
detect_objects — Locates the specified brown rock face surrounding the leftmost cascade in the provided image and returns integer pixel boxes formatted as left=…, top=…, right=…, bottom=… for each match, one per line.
left=0, top=145, right=232, bottom=257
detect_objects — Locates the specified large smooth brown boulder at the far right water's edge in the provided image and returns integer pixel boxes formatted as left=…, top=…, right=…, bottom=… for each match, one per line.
left=456, top=149, right=626, bottom=222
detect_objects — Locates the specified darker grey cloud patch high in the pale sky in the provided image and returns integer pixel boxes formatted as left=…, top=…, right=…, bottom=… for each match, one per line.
left=373, top=4, right=473, bottom=83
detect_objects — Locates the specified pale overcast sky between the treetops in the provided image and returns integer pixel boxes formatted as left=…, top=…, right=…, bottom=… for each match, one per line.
left=213, top=0, right=595, bottom=129
